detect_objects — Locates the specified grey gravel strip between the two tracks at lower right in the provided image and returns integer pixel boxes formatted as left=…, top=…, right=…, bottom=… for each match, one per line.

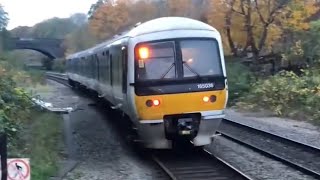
left=206, top=137, right=313, bottom=180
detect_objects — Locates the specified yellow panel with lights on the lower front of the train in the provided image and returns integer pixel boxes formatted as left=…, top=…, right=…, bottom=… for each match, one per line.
left=136, top=90, right=226, bottom=123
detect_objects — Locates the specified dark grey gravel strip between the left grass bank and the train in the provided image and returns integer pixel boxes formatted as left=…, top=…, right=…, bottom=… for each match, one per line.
left=40, top=80, right=164, bottom=180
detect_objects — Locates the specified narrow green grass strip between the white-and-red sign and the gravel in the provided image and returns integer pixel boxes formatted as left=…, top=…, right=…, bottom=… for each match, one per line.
left=30, top=110, right=62, bottom=180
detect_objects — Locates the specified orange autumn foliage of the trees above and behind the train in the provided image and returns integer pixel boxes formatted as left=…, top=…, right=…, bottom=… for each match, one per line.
left=89, top=0, right=319, bottom=56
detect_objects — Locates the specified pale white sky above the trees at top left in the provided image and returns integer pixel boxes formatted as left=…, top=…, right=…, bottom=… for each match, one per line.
left=0, top=0, right=97, bottom=30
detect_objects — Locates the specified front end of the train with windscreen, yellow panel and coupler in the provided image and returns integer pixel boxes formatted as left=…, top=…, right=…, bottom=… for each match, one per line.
left=129, top=17, right=228, bottom=149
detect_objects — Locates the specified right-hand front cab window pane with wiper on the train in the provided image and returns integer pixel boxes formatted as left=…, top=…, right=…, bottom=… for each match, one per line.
left=180, top=40, right=222, bottom=77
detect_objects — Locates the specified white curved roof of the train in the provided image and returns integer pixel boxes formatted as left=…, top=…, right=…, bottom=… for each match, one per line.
left=67, top=17, right=217, bottom=59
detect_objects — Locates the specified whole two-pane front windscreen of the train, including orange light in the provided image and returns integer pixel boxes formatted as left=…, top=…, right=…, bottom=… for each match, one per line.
left=136, top=39, right=223, bottom=81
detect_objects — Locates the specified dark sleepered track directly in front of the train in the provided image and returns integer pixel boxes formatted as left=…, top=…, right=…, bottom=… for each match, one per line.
left=152, top=148, right=251, bottom=180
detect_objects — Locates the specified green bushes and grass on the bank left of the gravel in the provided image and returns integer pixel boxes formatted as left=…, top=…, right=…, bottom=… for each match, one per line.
left=0, top=55, right=62, bottom=180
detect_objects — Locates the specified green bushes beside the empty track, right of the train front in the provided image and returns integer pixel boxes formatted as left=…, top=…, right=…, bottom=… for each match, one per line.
left=227, top=21, right=320, bottom=123
